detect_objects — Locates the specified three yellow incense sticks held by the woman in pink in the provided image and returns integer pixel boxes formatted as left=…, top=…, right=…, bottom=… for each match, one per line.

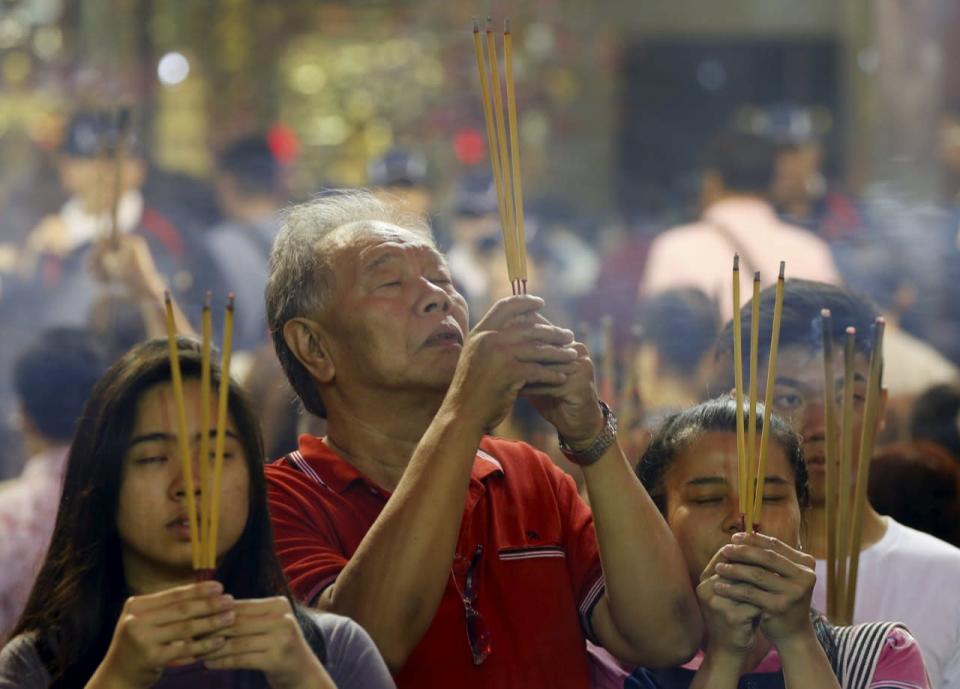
left=733, top=256, right=786, bottom=531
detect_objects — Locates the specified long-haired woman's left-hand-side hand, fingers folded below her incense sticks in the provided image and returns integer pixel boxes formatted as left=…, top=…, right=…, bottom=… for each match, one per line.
left=87, top=581, right=235, bottom=689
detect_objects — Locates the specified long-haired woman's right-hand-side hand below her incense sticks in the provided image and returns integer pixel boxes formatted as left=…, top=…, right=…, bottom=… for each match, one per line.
left=197, top=596, right=334, bottom=689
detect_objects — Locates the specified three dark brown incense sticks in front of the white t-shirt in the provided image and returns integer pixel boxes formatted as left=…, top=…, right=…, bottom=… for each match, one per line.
left=820, top=309, right=886, bottom=625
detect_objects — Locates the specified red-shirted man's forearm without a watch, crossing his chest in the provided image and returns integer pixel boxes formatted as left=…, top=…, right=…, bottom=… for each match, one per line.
left=321, top=398, right=483, bottom=671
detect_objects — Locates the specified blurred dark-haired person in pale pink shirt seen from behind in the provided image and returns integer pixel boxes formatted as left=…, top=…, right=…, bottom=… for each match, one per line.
left=640, top=132, right=840, bottom=316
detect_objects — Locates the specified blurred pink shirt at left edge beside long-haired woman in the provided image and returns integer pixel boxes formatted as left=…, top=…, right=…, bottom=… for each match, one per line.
left=0, top=446, right=69, bottom=645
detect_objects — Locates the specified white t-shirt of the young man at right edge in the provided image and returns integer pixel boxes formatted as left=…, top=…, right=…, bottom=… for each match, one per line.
left=813, top=517, right=960, bottom=689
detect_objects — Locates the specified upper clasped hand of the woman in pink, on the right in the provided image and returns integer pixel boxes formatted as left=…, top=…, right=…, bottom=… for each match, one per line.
left=715, top=533, right=817, bottom=647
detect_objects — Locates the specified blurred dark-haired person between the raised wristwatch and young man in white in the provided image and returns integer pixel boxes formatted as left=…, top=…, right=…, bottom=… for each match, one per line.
left=635, top=287, right=720, bottom=428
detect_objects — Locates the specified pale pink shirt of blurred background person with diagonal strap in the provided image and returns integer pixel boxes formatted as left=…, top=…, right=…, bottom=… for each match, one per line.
left=640, top=196, right=841, bottom=319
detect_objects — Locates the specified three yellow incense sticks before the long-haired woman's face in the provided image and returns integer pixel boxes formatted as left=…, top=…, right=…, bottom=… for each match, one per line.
left=164, top=292, right=234, bottom=579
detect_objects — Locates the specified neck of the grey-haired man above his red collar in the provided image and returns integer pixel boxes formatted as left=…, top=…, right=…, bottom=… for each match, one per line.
left=318, top=391, right=443, bottom=491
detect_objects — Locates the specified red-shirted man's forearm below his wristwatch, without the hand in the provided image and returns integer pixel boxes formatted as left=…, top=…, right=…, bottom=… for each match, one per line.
left=583, top=443, right=702, bottom=667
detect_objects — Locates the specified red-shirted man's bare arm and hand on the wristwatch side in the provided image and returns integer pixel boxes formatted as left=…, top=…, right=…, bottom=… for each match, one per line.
left=534, top=344, right=702, bottom=667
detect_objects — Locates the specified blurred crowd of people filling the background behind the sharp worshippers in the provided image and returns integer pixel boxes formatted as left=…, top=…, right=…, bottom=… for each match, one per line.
left=0, top=109, right=960, bottom=543
